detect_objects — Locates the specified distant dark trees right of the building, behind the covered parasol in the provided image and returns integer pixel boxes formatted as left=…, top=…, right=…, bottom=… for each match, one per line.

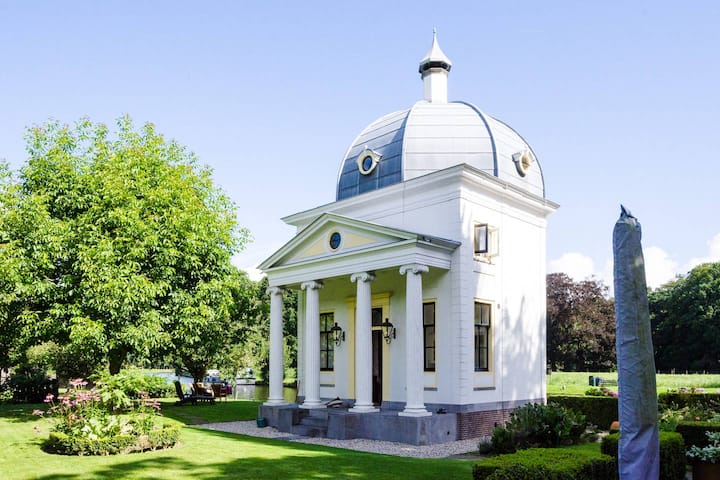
left=546, top=263, right=720, bottom=372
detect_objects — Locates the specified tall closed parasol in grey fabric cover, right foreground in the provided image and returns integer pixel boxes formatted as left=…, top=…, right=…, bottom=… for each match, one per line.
left=613, top=207, right=660, bottom=480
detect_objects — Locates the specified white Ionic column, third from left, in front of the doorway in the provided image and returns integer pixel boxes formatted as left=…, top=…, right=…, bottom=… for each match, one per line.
left=350, top=272, right=378, bottom=413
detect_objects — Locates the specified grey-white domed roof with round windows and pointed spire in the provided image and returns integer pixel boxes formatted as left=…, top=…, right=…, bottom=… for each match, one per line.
left=337, top=33, right=545, bottom=200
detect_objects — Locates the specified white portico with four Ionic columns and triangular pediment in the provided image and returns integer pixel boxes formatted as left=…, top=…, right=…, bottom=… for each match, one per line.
left=264, top=213, right=459, bottom=416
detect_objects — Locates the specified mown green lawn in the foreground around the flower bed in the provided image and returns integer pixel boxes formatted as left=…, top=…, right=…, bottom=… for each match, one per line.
left=0, top=401, right=472, bottom=480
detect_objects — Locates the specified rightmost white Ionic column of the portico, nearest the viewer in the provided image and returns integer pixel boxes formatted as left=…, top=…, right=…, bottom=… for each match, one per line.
left=398, top=263, right=432, bottom=417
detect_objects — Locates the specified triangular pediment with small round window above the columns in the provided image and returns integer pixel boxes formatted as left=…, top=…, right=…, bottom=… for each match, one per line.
left=260, top=213, right=454, bottom=270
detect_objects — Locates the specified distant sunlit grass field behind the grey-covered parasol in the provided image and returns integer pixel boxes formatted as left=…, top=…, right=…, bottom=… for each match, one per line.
left=547, top=372, right=720, bottom=395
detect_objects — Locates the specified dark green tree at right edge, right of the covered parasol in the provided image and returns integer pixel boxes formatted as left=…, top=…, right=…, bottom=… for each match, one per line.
left=648, top=262, right=720, bottom=371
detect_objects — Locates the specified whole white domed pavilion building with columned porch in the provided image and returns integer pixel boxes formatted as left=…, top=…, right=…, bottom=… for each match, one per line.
left=260, top=37, right=558, bottom=444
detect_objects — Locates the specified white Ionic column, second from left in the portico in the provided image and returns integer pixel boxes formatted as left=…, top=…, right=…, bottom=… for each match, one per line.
left=300, top=281, right=324, bottom=408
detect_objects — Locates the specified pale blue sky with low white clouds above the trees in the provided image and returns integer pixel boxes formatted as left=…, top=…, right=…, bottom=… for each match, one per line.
left=0, top=0, right=720, bottom=286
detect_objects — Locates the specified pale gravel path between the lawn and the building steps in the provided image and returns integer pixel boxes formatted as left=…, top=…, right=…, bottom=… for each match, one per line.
left=196, top=420, right=478, bottom=458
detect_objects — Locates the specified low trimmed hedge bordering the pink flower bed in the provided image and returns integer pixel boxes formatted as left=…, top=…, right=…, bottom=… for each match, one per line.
left=43, top=425, right=180, bottom=455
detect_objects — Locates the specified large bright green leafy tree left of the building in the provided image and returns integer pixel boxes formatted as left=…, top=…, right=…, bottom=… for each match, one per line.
left=0, top=117, right=247, bottom=374
